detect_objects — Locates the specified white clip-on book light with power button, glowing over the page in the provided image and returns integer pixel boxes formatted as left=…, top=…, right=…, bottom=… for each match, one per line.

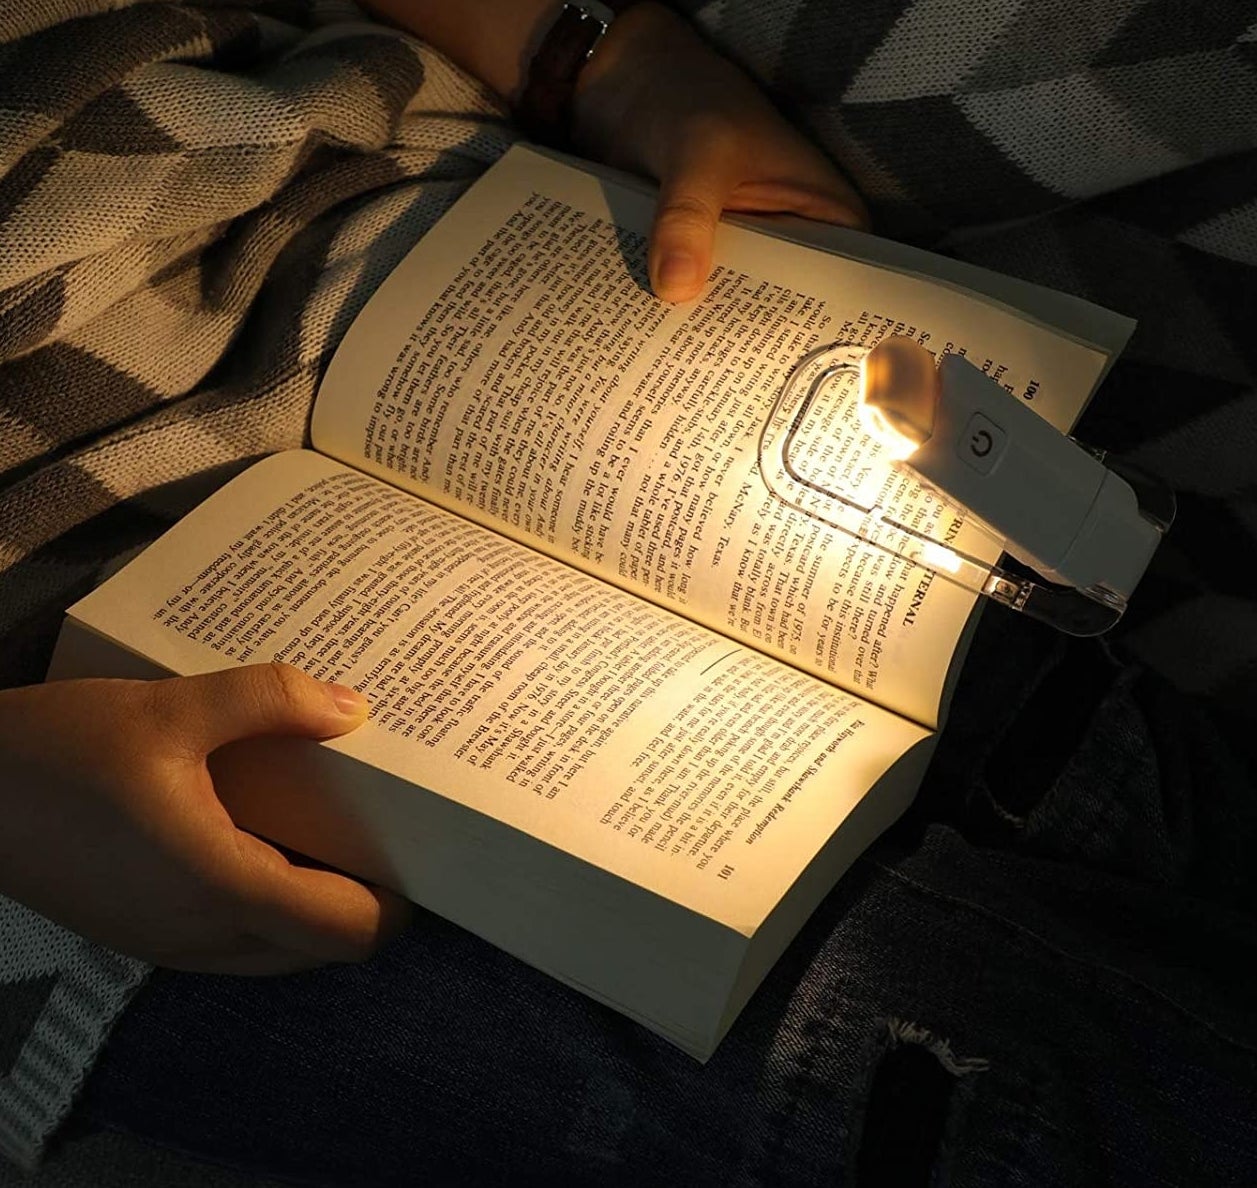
left=759, top=337, right=1174, bottom=635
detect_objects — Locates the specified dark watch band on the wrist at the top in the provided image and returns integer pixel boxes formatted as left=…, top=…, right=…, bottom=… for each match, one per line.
left=515, top=0, right=634, bottom=148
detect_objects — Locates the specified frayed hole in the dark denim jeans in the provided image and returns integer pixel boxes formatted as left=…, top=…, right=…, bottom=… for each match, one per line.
left=855, top=1020, right=987, bottom=1188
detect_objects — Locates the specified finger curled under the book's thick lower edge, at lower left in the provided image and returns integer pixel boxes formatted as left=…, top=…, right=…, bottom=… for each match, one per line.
left=225, top=832, right=414, bottom=962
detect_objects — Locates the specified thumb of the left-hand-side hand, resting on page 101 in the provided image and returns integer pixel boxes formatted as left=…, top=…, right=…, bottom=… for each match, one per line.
left=153, top=663, right=370, bottom=754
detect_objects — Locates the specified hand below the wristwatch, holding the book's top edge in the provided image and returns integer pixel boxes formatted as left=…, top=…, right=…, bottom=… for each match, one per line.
left=572, top=4, right=869, bottom=302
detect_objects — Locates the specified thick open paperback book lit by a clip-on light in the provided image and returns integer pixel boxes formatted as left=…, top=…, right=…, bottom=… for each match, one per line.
left=50, top=147, right=1130, bottom=1059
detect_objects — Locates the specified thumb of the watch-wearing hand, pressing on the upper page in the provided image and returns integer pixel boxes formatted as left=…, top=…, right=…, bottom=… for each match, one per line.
left=647, top=153, right=734, bottom=302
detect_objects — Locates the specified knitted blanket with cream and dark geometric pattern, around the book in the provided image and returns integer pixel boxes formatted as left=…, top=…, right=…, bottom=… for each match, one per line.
left=0, top=0, right=1257, bottom=1167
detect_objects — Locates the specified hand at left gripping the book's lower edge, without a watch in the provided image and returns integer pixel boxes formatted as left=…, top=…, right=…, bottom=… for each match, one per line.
left=0, top=664, right=410, bottom=974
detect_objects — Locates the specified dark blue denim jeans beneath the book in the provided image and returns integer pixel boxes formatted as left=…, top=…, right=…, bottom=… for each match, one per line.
left=71, top=598, right=1257, bottom=1185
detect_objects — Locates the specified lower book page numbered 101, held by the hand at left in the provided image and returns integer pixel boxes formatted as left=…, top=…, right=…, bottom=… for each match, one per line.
left=70, top=451, right=925, bottom=934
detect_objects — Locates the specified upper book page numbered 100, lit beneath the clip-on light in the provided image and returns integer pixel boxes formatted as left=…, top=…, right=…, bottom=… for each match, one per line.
left=313, top=150, right=1106, bottom=725
